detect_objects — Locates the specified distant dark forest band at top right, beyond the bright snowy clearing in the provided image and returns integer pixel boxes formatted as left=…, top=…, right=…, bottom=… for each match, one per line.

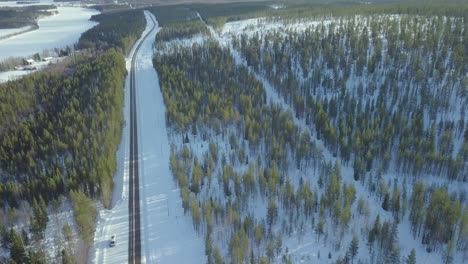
left=202, top=0, right=468, bottom=29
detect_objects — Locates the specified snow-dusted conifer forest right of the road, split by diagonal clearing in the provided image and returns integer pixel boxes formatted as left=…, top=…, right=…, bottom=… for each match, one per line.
left=154, top=4, right=468, bottom=263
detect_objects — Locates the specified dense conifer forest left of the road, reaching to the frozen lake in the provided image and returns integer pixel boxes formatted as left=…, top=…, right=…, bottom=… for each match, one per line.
left=0, top=7, right=146, bottom=263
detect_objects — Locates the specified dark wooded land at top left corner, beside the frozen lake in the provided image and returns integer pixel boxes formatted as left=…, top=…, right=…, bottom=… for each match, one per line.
left=0, top=5, right=56, bottom=29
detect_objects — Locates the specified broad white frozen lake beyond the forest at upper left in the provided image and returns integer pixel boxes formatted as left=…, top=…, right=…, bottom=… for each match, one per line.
left=0, top=6, right=99, bottom=61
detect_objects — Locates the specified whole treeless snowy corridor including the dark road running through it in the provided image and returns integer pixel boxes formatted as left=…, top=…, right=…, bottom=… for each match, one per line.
left=89, top=11, right=206, bottom=264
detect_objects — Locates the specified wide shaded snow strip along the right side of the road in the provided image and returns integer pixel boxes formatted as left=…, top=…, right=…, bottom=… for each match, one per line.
left=136, top=13, right=206, bottom=264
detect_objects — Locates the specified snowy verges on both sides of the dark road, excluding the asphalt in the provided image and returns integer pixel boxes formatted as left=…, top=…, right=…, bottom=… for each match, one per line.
left=90, top=9, right=206, bottom=263
